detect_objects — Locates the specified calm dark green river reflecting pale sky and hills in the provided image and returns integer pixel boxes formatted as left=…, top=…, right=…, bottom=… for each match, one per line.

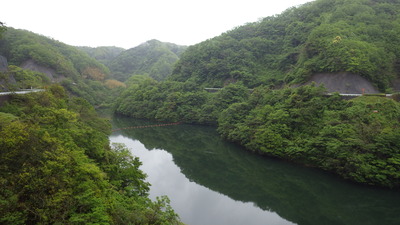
left=110, top=117, right=400, bottom=225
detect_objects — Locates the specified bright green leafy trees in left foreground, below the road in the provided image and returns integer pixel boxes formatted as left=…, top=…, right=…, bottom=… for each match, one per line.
left=0, top=86, right=179, bottom=224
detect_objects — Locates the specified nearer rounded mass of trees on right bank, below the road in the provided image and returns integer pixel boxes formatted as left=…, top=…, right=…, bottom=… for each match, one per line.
left=218, top=86, right=400, bottom=188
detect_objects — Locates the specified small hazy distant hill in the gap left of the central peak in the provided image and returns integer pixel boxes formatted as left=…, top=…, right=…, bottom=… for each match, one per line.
left=77, top=46, right=125, bottom=66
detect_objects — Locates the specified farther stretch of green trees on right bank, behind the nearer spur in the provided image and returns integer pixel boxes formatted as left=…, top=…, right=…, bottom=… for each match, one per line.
left=116, top=76, right=249, bottom=124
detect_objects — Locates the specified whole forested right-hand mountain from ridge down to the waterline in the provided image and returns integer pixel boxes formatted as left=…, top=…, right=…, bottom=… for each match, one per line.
left=116, top=0, right=400, bottom=188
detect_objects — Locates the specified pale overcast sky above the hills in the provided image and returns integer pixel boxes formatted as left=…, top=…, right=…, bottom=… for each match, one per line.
left=0, top=0, right=312, bottom=48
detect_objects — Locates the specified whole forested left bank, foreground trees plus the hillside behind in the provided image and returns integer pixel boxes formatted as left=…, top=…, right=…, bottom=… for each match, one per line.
left=0, top=23, right=181, bottom=224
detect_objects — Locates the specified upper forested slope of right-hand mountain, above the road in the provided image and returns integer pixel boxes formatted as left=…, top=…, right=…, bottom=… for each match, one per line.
left=171, top=0, right=400, bottom=91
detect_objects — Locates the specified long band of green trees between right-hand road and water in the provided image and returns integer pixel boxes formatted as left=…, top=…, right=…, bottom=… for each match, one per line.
left=116, top=82, right=400, bottom=189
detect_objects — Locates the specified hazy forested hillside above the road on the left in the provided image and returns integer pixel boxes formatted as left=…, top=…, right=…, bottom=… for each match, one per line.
left=0, top=27, right=124, bottom=104
